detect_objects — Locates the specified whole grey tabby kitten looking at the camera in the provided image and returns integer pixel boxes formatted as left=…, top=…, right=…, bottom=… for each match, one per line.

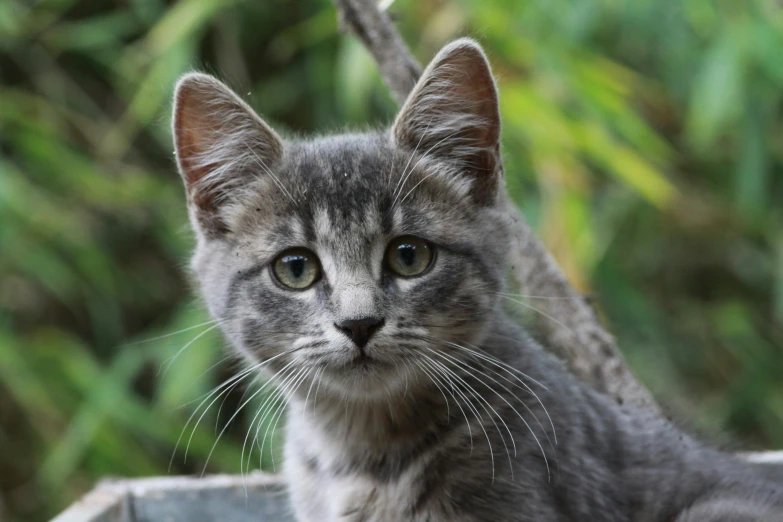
left=174, top=40, right=783, bottom=522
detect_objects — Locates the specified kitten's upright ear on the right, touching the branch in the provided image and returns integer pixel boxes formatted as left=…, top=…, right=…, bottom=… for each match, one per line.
left=392, top=38, right=502, bottom=202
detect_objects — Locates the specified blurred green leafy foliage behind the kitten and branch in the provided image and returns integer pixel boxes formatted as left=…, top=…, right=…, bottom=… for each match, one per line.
left=0, top=0, right=783, bottom=520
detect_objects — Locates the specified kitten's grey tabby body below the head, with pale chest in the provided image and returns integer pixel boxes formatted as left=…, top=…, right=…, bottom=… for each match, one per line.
left=286, top=308, right=783, bottom=522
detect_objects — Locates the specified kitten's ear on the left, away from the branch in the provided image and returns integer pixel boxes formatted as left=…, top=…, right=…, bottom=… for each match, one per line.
left=173, top=73, right=283, bottom=230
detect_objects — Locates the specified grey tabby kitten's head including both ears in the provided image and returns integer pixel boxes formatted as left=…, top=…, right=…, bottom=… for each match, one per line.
left=174, top=40, right=508, bottom=398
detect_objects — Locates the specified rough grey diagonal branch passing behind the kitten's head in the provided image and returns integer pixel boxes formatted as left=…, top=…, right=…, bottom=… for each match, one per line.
left=332, top=0, right=657, bottom=409
